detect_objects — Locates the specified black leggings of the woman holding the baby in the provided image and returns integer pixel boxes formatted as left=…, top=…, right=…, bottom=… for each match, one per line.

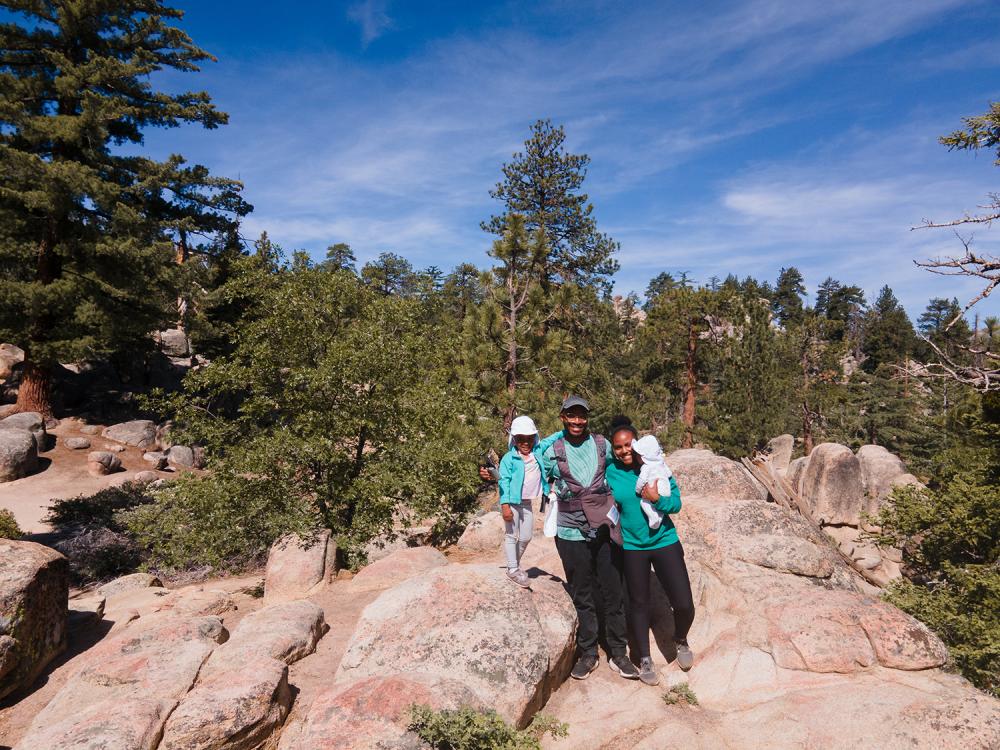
left=624, top=542, right=694, bottom=658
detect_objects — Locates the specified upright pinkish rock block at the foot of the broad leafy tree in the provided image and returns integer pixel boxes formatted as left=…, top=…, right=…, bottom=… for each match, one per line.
left=264, top=529, right=337, bottom=604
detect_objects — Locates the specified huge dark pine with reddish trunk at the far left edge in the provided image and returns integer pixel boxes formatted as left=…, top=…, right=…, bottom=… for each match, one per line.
left=0, top=0, right=250, bottom=413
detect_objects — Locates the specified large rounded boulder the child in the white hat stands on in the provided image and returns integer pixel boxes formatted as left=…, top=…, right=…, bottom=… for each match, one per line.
left=336, top=565, right=576, bottom=726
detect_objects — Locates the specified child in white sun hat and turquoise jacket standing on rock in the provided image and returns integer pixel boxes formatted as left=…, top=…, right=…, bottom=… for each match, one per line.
left=499, top=416, right=549, bottom=588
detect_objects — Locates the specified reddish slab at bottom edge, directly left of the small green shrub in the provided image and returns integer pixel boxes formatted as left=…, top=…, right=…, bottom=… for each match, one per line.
left=278, top=673, right=489, bottom=750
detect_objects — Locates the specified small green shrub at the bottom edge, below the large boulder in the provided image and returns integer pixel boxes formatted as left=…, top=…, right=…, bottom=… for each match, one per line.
left=409, top=705, right=568, bottom=750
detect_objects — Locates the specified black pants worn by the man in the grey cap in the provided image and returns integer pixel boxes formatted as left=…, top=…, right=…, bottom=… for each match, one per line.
left=556, top=526, right=628, bottom=656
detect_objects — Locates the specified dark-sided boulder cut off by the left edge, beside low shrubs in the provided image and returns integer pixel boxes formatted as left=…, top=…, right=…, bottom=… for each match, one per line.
left=0, top=539, right=69, bottom=698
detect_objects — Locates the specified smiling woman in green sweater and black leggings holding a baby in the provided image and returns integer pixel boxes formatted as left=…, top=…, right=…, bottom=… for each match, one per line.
left=604, top=417, right=694, bottom=685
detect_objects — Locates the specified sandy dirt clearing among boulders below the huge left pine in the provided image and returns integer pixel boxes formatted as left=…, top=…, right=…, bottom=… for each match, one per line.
left=0, top=418, right=184, bottom=534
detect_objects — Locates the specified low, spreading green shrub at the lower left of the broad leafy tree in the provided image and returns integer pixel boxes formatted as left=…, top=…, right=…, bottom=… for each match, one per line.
left=117, top=470, right=319, bottom=571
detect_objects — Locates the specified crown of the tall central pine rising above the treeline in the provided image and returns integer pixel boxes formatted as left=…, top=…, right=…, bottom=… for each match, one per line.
left=482, top=120, right=618, bottom=291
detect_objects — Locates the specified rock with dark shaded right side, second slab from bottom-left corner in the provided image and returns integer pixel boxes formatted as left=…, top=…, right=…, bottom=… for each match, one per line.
left=159, top=657, right=292, bottom=750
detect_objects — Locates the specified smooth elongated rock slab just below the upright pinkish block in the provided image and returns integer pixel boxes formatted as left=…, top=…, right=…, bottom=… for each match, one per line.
left=205, top=600, right=327, bottom=674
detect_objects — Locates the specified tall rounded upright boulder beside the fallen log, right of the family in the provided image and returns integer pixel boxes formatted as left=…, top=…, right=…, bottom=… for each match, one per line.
left=800, top=443, right=864, bottom=526
